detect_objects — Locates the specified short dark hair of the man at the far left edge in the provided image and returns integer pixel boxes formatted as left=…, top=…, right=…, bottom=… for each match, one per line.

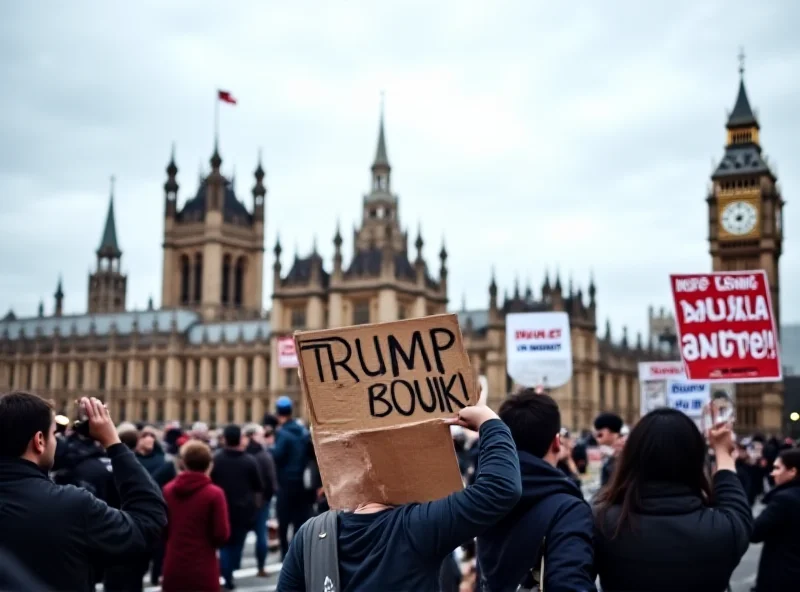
left=0, top=391, right=53, bottom=458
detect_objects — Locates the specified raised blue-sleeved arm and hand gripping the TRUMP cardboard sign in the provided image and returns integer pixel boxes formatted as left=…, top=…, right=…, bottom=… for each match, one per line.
left=405, top=406, right=522, bottom=560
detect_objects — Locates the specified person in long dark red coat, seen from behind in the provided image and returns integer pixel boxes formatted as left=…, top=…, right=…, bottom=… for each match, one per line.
left=161, top=440, right=231, bottom=592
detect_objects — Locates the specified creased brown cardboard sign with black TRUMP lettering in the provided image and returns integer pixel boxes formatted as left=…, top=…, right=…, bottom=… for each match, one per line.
left=294, top=315, right=478, bottom=510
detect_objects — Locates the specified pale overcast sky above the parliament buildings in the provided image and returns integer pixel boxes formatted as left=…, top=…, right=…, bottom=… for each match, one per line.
left=0, top=0, right=800, bottom=338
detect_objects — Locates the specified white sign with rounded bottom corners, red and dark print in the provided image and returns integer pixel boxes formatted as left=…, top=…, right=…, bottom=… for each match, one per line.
left=506, top=312, right=572, bottom=388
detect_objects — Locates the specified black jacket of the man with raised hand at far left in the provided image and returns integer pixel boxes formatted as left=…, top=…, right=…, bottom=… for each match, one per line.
left=0, top=444, right=167, bottom=592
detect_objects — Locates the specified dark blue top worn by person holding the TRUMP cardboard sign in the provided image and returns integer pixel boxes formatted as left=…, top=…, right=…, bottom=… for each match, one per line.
left=278, top=419, right=520, bottom=592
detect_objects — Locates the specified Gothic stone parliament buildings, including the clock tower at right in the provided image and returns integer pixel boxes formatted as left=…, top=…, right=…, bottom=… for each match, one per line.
left=0, top=70, right=784, bottom=431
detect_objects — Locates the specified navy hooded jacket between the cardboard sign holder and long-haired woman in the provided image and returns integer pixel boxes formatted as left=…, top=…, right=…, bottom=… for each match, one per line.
left=478, top=451, right=597, bottom=592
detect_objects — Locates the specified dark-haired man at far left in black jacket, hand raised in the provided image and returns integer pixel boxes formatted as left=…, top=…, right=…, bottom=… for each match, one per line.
left=0, top=391, right=167, bottom=591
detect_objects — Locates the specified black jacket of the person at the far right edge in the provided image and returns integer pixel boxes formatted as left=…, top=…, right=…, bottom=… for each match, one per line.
left=750, top=479, right=800, bottom=592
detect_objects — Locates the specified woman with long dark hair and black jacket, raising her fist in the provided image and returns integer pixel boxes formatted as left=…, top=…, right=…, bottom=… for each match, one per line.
left=594, top=409, right=753, bottom=592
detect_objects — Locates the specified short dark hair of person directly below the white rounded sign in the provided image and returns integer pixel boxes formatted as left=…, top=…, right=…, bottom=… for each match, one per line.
left=498, top=389, right=561, bottom=458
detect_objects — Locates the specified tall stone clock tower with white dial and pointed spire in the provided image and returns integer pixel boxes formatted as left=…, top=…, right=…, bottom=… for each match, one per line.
left=706, top=55, right=784, bottom=433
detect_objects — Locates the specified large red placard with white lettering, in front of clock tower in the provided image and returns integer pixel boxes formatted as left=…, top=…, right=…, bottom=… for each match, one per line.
left=670, top=270, right=782, bottom=382
